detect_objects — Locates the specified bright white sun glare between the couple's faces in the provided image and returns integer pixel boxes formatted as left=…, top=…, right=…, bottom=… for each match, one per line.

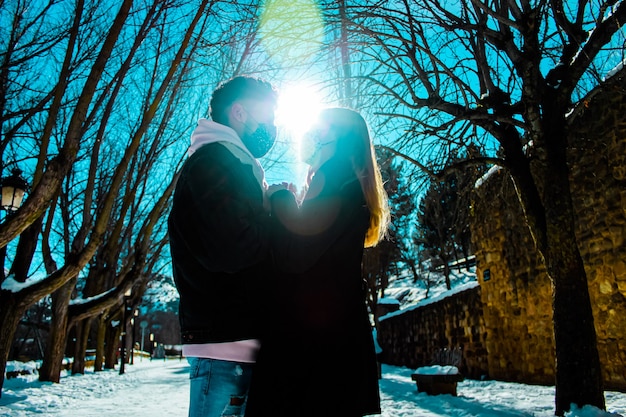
left=276, top=85, right=322, bottom=136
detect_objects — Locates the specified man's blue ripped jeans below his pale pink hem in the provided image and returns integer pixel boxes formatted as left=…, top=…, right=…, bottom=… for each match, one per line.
left=188, top=358, right=254, bottom=417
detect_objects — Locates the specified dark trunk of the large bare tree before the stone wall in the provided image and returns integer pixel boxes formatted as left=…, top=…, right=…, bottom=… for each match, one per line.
left=544, top=170, right=605, bottom=416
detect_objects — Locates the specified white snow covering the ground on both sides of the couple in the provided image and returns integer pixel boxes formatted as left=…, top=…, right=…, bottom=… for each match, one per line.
left=0, top=359, right=626, bottom=417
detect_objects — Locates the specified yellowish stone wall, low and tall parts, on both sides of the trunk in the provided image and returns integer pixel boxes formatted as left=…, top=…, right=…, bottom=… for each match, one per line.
left=378, top=70, right=626, bottom=391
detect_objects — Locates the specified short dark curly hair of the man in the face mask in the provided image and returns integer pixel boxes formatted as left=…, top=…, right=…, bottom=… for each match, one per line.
left=209, top=76, right=278, bottom=125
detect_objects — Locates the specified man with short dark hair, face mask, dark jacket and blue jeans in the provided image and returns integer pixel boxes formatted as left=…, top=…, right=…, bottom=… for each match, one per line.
left=168, top=76, right=277, bottom=417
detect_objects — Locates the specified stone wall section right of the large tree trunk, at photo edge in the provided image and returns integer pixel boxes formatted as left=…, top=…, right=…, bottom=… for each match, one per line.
left=570, top=70, right=626, bottom=390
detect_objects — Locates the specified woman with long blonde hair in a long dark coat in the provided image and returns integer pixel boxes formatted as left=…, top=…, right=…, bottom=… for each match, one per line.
left=246, top=108, right=389, bottom=417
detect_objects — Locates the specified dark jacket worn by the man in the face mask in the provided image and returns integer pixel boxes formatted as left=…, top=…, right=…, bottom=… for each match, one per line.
left=168, top=143, right=270, bottom=344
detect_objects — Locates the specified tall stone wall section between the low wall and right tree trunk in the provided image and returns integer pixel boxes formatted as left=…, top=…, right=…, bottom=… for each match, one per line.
left=472, top=170, right=555, bottom=384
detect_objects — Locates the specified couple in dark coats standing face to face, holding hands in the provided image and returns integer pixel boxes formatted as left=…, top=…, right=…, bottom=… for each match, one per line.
left=168, top=76, right=389, bottom=417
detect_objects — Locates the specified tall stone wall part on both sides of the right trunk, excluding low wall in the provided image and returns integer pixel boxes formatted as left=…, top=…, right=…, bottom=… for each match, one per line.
left=472, top=71, right=626, bottom=390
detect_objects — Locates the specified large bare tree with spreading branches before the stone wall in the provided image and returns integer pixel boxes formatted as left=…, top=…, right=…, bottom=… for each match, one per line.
left=342, top=0, right=626, bottom=415
